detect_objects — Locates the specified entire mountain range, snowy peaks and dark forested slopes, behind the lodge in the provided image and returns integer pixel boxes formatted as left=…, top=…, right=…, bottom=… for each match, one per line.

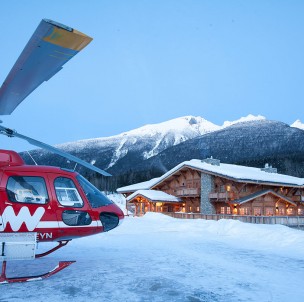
left=22, top=115, right=304, bottom=188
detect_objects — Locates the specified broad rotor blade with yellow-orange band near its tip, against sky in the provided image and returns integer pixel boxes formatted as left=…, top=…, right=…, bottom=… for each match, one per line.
left=0, top=19, right=92, bottom=115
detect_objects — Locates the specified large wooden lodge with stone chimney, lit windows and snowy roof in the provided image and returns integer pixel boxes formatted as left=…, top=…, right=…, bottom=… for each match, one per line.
left=117, top=158, right=304, bottom=223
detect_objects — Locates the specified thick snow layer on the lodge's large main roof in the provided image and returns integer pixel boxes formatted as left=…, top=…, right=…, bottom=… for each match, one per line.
left=117, top=159, right=304, bottom=192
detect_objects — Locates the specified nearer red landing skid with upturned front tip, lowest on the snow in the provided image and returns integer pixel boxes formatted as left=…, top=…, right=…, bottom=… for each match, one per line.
left=0, top=261, right=75, bottom=284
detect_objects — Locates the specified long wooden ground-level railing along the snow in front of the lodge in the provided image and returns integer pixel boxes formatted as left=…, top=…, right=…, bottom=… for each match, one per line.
left=163, top=212, right=304, bottom=227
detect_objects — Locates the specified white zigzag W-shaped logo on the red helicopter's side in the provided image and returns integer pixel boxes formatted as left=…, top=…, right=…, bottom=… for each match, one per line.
left=0, top=206, right=45, bottom=232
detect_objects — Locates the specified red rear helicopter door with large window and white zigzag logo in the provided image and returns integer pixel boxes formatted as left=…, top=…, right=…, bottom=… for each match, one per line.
left=1, top=171, right=58, bottom=237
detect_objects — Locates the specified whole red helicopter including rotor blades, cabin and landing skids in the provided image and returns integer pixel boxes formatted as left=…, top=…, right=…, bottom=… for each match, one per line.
left=0, top=19, right=124, bottom=284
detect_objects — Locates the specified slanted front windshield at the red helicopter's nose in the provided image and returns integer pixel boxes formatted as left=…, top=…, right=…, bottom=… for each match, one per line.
left=76, top=175, right=113, bottom=208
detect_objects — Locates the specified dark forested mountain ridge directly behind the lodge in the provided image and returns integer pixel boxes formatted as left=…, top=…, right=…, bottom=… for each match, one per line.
left=140, top=119, right=304, bottom=177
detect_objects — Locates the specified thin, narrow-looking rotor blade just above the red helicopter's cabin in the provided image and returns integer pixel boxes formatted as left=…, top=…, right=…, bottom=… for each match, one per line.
left=0, top=125, right=111, bottom=176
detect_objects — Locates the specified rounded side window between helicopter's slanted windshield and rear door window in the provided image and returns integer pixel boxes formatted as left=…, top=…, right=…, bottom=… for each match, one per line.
left=54, top=177, right=83, bottom=208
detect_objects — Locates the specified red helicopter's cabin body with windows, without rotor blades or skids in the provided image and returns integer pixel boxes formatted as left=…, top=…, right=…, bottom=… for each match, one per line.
left=0, top=150, right=124, bottom=242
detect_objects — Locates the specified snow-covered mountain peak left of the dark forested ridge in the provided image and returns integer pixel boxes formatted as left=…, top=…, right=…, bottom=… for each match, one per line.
left=23, top=116, right=221, bottom=170
